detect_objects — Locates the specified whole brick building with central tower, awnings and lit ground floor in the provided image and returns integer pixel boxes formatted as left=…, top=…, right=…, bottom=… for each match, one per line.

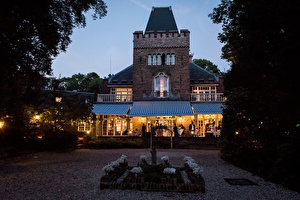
left=93, top=7, right=223, bottom=137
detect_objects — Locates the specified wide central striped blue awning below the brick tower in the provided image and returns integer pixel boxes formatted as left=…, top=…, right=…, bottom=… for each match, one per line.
left=129, top=101, right=194, bottom=117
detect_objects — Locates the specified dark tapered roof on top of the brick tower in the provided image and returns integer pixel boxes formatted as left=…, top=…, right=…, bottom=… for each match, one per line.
left=145, top=6, right=178, bottom=33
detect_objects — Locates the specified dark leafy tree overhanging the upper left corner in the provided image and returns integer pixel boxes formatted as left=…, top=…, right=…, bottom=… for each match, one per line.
left=0, top=0, right=107, bottom=126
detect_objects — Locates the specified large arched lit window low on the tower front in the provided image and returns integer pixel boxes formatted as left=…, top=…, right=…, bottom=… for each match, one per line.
left=154, top=73, right=169, bottom=98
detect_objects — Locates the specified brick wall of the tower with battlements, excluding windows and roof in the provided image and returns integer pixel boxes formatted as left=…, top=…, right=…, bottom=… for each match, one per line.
left=133, top=30, right=190, bottom=101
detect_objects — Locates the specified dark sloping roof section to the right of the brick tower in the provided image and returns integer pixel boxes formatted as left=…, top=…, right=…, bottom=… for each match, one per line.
left=189, top=62, right=219, bottom=84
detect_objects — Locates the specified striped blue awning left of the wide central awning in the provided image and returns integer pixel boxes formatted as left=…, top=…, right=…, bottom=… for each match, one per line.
left=92, top=103, right=132, bottom=115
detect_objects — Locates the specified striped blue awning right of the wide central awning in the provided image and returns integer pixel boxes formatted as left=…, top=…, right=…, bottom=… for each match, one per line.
left=191, top=102, right=222, bottom=114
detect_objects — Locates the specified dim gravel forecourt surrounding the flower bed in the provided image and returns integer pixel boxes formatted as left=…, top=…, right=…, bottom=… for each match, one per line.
left=0, top=149, right=300, bottom=200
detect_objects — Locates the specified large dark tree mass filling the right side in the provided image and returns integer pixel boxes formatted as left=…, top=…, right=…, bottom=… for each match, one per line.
left=209, top=0, right=300, bottom=190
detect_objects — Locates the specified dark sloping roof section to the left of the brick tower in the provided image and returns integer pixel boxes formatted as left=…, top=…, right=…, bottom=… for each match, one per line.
left=108, top=65, right=133, bottom=85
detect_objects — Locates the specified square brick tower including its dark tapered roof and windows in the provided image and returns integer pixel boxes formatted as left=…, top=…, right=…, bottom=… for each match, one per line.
left=132, top=7, right=190, bottom=101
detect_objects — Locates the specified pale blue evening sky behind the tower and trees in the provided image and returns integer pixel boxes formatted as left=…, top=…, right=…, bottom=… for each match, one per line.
left=52, top=0, right=229, bottom=78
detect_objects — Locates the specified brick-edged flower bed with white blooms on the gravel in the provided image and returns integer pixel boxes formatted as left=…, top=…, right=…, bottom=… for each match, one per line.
left=100, top=155, right=205, bottom=193
